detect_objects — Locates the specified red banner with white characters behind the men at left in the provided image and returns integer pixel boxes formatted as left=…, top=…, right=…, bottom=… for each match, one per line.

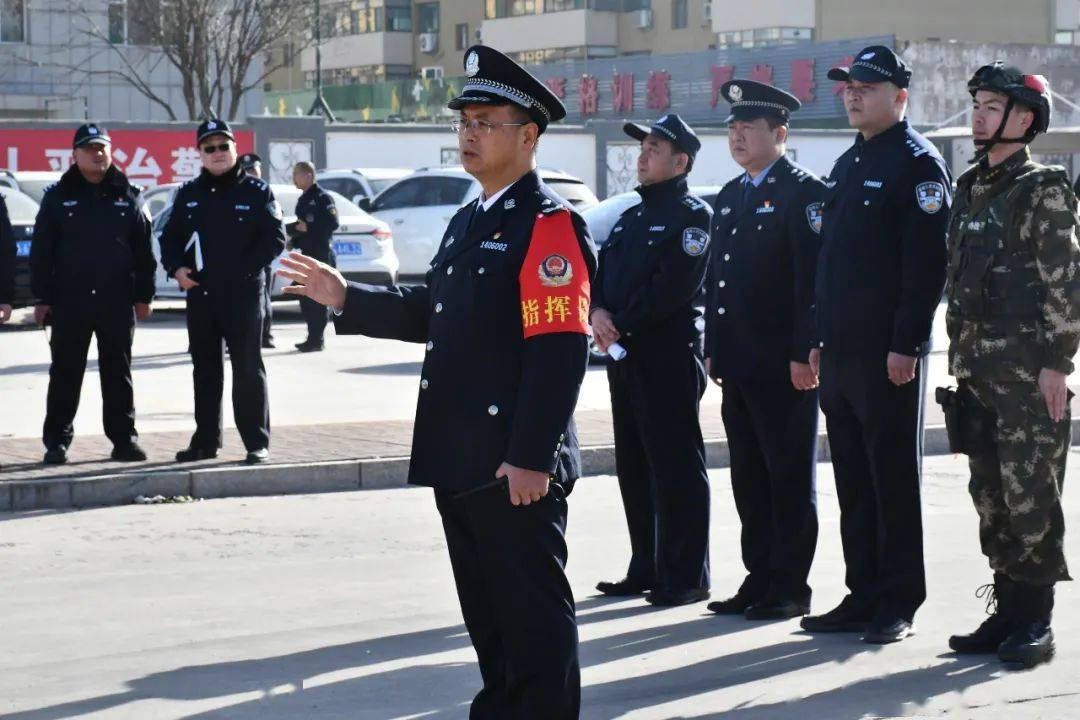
left=0, top=125, right=255, bottom=187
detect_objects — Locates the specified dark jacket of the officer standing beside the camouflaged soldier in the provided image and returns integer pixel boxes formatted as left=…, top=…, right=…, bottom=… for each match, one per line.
left=815, top=120, right=953, bottom=356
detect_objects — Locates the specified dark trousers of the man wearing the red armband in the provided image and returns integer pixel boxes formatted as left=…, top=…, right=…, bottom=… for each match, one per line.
left=435, top=485, right=581, bottom=720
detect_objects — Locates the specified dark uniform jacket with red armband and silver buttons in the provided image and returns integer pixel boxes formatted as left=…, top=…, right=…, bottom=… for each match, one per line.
left=335, top=172, right=596, bottom=493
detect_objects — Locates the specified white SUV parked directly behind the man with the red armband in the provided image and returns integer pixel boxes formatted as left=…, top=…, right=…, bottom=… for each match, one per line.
left=370, top=165, right=597, bottom=277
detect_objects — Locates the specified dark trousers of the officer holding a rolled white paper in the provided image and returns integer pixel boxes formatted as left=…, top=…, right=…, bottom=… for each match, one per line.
left=608, top=342, right=710, bottom=592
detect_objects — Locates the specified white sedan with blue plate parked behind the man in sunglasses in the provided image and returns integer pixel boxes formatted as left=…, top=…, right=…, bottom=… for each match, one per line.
left=145, top=185, right=399, bottom=298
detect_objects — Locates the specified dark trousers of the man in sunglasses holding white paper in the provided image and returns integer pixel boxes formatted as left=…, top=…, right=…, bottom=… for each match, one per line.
left=188, top=280, right=270, bottom=452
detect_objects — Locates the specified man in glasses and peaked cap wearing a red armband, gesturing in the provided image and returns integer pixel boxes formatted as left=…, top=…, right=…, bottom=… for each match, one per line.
left=282, top=45, right=596, bottom=720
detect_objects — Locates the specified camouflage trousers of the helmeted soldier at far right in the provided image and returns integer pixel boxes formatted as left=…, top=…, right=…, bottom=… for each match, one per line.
left=962, top=379, right=1071, bottom=585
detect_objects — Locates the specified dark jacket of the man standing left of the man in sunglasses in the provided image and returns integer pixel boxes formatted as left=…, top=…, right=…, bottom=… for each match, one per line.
left=30, top=165, right=157, bottom=304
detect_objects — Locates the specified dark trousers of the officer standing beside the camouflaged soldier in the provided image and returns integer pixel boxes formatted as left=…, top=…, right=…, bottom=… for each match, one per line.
left=821, top=349, right=927, bottom=621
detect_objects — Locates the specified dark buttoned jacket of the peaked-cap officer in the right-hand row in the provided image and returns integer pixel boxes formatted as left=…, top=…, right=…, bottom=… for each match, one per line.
left=705, top=158, right=825, bottom=382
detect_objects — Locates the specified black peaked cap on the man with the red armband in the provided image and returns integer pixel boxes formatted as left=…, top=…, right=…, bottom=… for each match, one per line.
left=446, top=45, right=566, bottom=133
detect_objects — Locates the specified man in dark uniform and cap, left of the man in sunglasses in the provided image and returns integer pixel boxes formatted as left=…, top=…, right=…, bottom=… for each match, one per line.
left=30, top=123, right=156, bottom=464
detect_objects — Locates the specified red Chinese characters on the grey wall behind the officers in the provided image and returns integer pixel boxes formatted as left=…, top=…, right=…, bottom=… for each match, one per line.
left=544, top=55, right=854, bottom=116
